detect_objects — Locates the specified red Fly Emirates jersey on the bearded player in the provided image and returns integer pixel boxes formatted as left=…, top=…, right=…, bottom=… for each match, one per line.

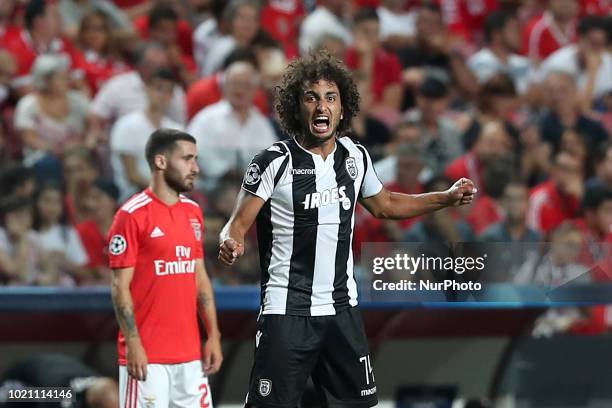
left=108, top=189, right=204, bottom=365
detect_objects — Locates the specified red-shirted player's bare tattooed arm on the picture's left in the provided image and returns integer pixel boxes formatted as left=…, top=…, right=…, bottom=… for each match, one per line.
left=111, top=268, right=148, bottom=381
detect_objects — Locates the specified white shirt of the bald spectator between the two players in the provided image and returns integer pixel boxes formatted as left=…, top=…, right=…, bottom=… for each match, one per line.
left=187, top=100, right=277, bottom=182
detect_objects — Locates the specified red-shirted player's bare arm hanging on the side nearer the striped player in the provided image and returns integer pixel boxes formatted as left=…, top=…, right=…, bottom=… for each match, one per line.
left=196, top=258, right=223, bottom=375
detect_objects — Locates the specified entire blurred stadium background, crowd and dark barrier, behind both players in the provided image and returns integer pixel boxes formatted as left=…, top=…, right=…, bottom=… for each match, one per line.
left=0, top=0, right=612, bottom=408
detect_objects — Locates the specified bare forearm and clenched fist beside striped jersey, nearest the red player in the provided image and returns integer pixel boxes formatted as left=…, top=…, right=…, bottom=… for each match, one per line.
left=219, top=190, right=264, bottom=265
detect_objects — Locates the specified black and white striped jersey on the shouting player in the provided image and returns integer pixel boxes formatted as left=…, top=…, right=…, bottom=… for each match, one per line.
left=242, top=137, right=382, bottom=316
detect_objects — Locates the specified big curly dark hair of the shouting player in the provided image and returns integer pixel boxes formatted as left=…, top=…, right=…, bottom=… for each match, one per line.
left=275, top=50, right=359, bottom=136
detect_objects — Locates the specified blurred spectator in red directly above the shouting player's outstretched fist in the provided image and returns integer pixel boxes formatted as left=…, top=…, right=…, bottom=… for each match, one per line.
left=444, top=121, right=514, bottom=193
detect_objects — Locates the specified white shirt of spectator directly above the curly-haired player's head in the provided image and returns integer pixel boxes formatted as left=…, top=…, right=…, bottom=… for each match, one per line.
left=299, top=6, right=353, bottom=55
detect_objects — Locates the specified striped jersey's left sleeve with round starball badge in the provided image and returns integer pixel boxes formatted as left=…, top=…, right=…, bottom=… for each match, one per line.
left=242, top=143, right=288, bottom=201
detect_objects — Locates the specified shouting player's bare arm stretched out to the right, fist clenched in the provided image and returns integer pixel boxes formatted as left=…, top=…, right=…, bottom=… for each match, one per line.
left=361, top=178, right=477, bottom=220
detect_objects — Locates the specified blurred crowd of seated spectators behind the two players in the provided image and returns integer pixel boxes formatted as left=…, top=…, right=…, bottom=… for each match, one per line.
left=0, top=0, right=612, bottom=312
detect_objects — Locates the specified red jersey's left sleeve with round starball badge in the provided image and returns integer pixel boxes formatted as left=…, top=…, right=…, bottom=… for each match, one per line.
left=108, top=210, right=139, bottom=269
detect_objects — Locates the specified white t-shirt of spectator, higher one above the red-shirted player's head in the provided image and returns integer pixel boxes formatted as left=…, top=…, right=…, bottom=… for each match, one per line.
left=91, top=71, right=187, bottom=123
